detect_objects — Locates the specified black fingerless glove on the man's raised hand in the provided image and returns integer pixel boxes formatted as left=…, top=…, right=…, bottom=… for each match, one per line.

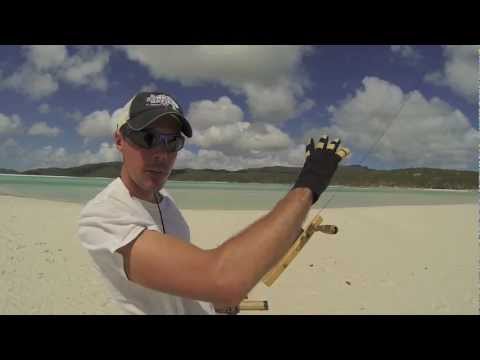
left=292, top=137, right=341, bottom=205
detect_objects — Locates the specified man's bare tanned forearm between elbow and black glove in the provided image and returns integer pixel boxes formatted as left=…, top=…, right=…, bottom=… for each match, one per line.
left=215, top=188, right=312, bottom=301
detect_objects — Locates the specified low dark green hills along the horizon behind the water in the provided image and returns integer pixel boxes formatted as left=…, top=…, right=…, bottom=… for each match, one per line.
left=0, top=162, right=478, bottom=189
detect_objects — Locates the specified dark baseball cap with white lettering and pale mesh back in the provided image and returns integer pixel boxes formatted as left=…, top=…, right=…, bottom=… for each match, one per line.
left=117, top=92, right=192, bottom=138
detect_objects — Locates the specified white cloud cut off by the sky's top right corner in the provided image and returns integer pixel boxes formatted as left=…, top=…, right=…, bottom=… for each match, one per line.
left=424, top=45, right=480, bottom=103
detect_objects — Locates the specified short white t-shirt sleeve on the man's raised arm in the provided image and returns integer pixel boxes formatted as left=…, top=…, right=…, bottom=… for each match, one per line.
left=78, top=199, right=148, bottom=253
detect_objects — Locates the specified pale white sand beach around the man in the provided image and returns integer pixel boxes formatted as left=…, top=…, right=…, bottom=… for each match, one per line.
left=0, top=196, right=479, bottom=315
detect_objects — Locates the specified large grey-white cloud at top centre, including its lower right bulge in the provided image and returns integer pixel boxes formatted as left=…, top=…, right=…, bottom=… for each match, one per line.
left=118, top=45, right=313, bottom=123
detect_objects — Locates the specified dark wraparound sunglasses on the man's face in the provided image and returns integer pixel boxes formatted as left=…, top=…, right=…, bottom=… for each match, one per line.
left=122, top=126, right=185, bottom=152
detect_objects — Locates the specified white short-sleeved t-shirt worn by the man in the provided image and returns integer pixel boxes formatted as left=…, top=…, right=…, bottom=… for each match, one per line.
left=78, top=178, right=215, bottom=315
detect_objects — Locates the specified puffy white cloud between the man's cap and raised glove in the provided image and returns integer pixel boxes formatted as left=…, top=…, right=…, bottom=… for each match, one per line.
left=177, top=96, right=304, bottom=170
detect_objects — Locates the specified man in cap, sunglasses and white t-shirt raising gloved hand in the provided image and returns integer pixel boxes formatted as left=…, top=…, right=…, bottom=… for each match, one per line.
left=78, top=92, right=348, bottom=314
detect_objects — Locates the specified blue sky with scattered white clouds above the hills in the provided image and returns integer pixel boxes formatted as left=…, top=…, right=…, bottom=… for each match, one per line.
left=0, top=45, right=480, bottom=171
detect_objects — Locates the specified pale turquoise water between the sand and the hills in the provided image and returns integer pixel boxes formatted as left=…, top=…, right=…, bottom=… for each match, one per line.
left=0, top=175, right=478, bottom=210
